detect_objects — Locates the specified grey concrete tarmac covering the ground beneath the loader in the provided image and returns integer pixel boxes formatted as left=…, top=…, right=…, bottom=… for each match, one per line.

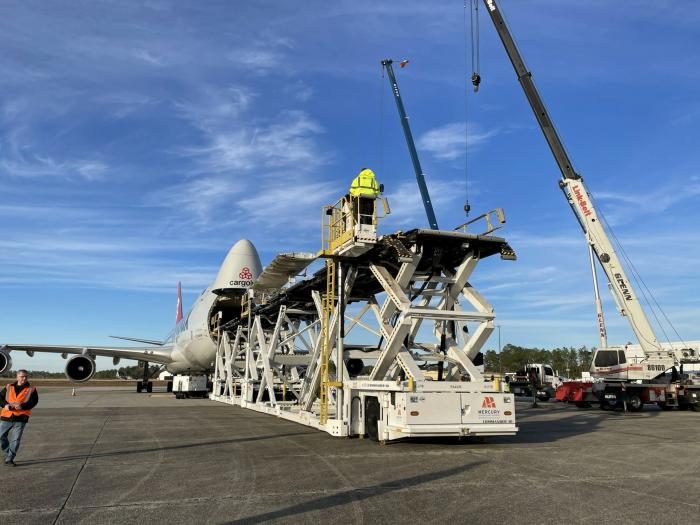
left=0, top=387, right=700, bottom=525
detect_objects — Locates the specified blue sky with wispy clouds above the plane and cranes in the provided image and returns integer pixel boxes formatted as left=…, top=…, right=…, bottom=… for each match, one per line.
left=0, top=0, right=700, bottom=370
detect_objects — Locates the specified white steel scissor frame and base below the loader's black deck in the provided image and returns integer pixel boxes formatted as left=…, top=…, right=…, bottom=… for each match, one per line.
left=212, top=231, right=517, bottom=439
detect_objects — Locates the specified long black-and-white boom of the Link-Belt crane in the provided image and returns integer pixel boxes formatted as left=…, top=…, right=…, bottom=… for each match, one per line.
left=483, top=0, right=669, bottom=376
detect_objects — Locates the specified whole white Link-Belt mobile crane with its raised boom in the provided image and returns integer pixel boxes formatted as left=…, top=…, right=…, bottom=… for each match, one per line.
left=484, top=0, right=700, bottom=409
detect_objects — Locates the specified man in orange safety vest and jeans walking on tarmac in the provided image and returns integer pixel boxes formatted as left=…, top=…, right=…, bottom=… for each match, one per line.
left=0, top=370, right=39, bottom=467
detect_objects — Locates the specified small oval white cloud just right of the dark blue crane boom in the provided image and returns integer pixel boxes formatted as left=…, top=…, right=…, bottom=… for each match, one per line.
left=418, top=122, right=499, bottom=160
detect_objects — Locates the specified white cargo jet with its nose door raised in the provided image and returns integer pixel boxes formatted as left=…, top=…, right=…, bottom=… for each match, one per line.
left=0, top=239, right=262, bottom=391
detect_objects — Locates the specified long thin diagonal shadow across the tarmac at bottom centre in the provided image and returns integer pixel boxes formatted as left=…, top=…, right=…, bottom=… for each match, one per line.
left=225, top=461, right=486, bottom=525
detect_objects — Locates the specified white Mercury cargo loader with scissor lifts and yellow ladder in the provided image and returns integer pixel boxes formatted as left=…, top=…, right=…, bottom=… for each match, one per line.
left=210, top=198, right=517, bottom=441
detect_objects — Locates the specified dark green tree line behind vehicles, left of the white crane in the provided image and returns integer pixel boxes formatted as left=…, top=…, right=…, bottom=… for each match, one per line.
left=484, top=344, right=595, bottom=377
